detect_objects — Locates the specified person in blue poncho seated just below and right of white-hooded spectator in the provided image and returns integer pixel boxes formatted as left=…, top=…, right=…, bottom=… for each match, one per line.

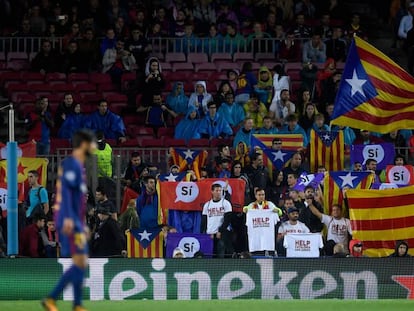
left=198, top=101, right=233, bottom=139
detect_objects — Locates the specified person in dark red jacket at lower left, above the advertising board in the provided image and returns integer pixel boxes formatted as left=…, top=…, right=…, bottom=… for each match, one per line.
left=19, top=215, right=46, bottom=257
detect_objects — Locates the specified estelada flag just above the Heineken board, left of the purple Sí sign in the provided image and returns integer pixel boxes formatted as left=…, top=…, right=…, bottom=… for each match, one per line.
left=126, top=228, right=164, bottom=258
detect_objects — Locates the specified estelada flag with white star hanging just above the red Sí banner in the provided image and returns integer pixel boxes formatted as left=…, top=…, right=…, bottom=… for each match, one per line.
left=170, top=148, right=208, bottom=179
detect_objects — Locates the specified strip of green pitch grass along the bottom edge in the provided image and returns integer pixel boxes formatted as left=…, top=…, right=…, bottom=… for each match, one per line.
left=0, top=300, right=414, bottom=311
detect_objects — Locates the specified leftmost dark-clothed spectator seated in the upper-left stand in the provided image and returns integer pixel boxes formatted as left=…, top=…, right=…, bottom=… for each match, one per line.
left=32, top=39, right=60, bottom=74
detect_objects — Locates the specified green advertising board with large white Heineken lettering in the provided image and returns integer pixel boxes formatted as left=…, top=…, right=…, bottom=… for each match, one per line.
left=0, top=258, right=414, bottom=300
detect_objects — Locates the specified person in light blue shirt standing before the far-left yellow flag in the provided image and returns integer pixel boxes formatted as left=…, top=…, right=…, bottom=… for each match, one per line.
left=26, top=170, right=50, bottom=218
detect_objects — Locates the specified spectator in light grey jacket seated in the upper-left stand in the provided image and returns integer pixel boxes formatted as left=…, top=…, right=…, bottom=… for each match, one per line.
left=102, top=40, right=135, bottom=87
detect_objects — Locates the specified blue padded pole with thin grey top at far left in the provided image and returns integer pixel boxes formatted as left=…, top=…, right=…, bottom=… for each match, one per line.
left=3, top=104, right=19, bottom=257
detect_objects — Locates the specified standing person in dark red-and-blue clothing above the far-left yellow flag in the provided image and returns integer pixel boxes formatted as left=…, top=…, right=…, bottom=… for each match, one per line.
left=25, top=96, right=54, bottom=155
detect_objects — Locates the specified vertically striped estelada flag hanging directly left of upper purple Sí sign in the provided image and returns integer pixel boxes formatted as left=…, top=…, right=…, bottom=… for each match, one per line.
left=309, top=129, right=345, bottom=172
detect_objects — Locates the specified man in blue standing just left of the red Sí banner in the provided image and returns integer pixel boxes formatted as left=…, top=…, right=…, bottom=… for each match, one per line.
left=136, top=176, right=159, bottom=229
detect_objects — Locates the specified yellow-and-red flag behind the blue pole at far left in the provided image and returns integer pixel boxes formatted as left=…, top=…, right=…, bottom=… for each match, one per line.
left=0, top=158, right=49, bottom=189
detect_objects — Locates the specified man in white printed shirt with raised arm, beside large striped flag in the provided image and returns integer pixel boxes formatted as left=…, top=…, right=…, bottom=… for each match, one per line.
left=307, top=200, right=352, bottom=256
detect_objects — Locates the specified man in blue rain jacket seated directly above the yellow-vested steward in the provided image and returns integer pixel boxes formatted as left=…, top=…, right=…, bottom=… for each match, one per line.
left=86, top=99, right=126, bottom=142
